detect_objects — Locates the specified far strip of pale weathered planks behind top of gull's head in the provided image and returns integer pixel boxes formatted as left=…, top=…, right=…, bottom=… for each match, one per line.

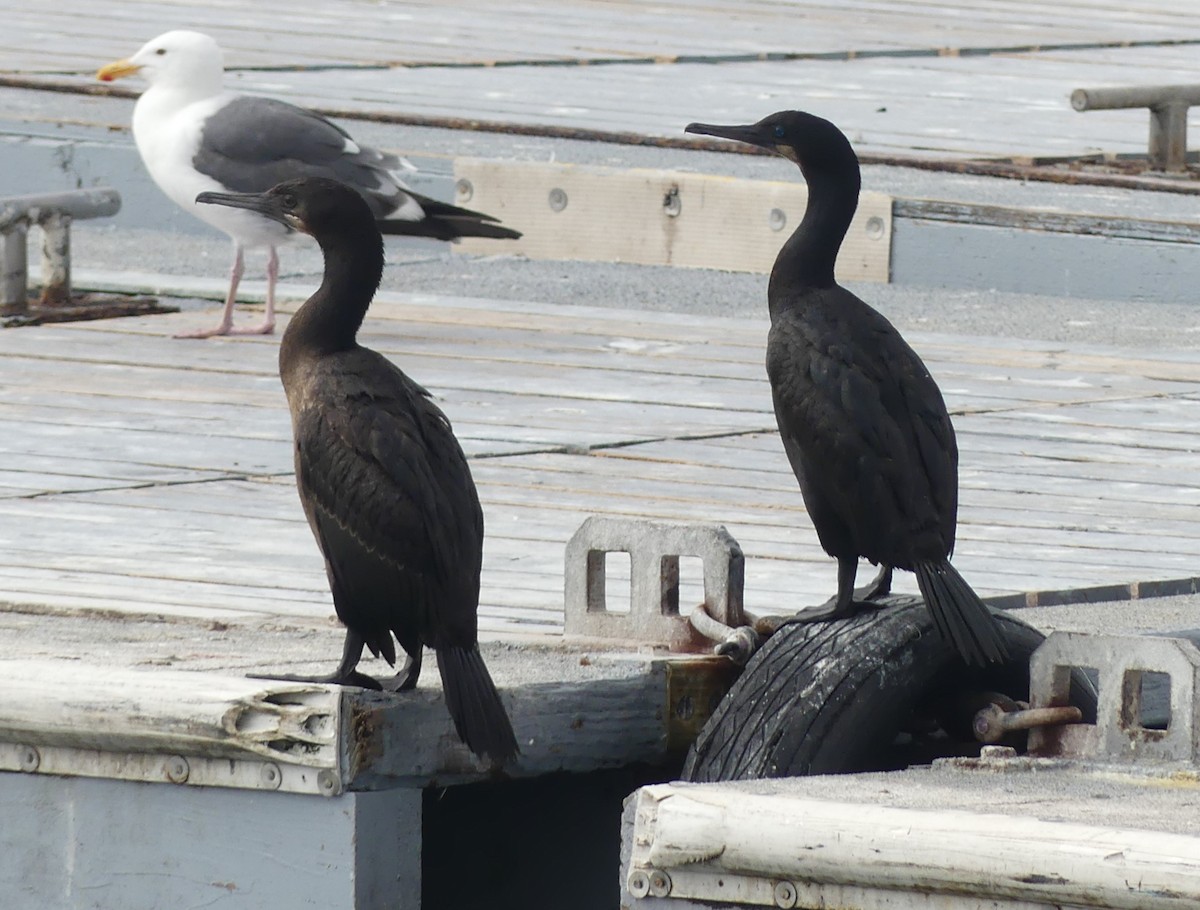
left=0, top=0, right=1196, bottom=72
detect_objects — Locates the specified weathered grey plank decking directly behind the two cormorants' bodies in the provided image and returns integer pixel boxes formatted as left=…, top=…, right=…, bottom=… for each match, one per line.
left=7, top=280, right=1200, bottom=660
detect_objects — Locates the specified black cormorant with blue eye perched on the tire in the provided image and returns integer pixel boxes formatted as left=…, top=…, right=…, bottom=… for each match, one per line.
left=686, top=110, right=1006, bottom=664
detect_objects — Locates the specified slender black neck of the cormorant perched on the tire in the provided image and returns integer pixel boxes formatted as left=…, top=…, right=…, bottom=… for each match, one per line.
left=768, top=156, right=862, bottom=312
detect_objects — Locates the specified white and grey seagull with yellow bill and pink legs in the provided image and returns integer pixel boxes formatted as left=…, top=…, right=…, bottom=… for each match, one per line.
left=96, top=30, right=521, bottom=339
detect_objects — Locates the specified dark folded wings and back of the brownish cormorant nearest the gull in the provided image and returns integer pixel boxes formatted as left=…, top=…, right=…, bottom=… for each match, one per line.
left=295, top=351, right=484, bottom=654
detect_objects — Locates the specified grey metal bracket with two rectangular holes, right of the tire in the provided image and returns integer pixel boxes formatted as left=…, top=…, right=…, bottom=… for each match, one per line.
left=1030, top=631, right=1200, bottom=764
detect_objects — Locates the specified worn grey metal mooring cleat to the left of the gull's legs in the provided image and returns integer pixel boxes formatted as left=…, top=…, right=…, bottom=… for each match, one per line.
left=0, top=188, right=121, bottom=310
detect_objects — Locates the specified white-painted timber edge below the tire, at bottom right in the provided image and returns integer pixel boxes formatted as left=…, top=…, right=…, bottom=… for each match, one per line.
left=631, top=784, right=1200, bottom=910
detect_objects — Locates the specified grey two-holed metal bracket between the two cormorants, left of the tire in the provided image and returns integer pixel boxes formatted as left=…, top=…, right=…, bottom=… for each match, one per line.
left=564, top=515, right=745, bottom=652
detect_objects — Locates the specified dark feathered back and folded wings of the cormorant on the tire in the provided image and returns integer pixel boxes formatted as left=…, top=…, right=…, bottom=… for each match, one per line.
left=767, top=288, right=958, bottom=567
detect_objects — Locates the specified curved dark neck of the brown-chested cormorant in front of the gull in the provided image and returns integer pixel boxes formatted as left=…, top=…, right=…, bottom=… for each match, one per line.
left=280, top=224, right=383, bottom=360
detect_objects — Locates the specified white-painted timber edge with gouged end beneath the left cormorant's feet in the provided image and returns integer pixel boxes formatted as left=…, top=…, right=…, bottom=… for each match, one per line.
left=0, top=660, right=347, bottom=796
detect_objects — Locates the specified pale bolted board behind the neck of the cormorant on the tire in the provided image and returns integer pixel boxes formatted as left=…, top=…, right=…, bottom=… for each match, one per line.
left=455, top=158, right=892, bottom=282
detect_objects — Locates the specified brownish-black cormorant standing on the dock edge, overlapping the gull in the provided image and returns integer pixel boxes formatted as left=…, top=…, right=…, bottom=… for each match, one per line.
left=197, top=178, right=517, bottom=762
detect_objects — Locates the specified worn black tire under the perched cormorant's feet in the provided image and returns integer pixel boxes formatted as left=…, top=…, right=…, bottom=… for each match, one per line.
left=682, top=597, right=1096, bottom=780
